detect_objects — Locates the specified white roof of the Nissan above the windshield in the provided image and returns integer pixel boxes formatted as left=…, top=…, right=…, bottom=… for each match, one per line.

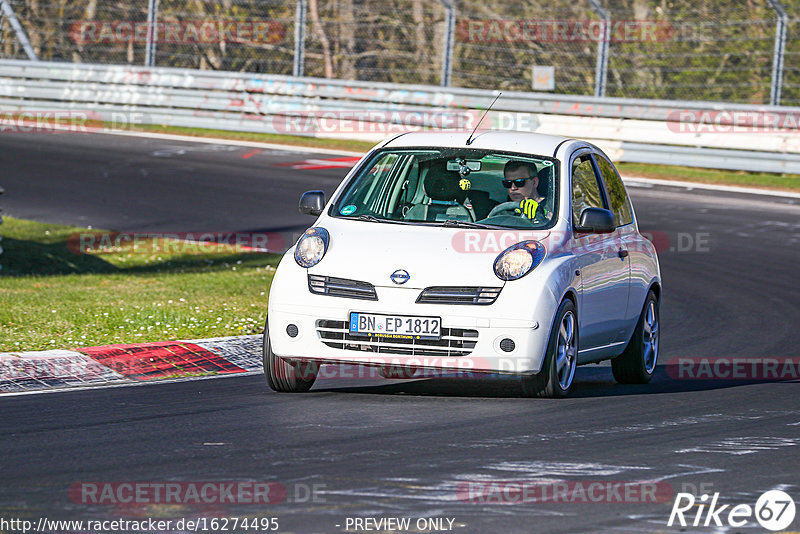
left=384, top=130, right=573, bottom=157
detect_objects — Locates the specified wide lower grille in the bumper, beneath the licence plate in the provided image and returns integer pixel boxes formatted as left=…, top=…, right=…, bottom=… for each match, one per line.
left=317, top=319, right=478, bottom=356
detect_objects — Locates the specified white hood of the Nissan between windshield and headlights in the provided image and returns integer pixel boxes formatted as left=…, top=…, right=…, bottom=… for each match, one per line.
left=309, top=218, right=549, bottom=289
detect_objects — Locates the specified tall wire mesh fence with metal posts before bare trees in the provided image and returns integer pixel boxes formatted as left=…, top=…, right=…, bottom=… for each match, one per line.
left=0, top=0, right=800, bottom=105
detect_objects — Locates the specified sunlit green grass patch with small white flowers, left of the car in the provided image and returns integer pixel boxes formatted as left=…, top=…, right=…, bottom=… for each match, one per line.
left=0, top=217, right=280, bottom=351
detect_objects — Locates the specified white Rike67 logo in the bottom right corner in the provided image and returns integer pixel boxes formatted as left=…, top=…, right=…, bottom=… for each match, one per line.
left=667, top=490, right=795, bottom=531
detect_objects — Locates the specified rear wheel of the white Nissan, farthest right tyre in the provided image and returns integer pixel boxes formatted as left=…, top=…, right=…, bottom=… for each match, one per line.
left=611, top=290, right=661, bottom=384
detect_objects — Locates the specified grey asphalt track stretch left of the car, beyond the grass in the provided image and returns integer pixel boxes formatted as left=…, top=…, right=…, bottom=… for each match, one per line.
left=0, top=134, right=349, bottom=232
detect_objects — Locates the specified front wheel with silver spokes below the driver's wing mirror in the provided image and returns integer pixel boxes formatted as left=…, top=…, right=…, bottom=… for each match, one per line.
left=522, top=299, right=578, bottom=398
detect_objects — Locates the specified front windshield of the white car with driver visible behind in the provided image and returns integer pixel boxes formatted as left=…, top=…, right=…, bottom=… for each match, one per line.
left=331, top=148, right=558, bottom=228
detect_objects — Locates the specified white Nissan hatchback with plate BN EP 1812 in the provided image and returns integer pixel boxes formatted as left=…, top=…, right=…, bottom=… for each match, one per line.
left=264, top=131, right=661, bottom=397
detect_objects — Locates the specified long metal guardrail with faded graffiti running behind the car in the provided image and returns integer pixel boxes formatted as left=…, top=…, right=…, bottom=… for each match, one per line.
left=0, top=60, right=800, bottom=174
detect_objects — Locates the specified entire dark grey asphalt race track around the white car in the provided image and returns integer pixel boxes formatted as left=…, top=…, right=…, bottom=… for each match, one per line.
left=0, top=134, right=800, bottom=533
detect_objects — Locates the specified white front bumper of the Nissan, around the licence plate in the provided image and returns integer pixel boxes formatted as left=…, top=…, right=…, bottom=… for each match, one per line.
left=268, top=261, right=559, bottom=374
